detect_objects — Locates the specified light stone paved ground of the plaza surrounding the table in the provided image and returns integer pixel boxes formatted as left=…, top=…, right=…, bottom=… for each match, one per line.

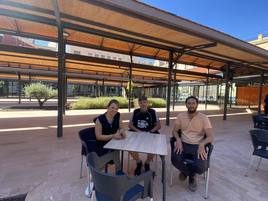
left=0, top=99, right=268, bottom=201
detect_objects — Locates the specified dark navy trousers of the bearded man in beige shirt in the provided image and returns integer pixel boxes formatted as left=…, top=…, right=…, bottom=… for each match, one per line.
left=171, top=142, right=208, bottom=176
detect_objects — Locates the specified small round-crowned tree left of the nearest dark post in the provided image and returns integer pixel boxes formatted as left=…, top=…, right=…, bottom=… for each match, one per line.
left=24, top=82, right=57, bottom=108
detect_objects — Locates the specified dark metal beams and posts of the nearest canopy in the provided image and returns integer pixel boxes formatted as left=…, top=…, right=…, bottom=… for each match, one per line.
left=0, top=0, right=268, bottom=137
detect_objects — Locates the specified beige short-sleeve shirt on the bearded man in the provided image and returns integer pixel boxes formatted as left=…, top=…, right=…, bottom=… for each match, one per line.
left=175, top=112, right=212, bottom=144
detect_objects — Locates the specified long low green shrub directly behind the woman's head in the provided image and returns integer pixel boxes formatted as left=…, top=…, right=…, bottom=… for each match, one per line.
left=71, top=97, right=128, bottom=110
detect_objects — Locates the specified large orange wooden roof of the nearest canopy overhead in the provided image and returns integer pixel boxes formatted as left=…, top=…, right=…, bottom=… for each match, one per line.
left=0, top=0, right=268, bottom=77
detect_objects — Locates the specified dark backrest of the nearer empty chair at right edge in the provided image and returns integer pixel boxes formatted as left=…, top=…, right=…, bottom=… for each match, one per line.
left=249, top=129, right=268, bottom=151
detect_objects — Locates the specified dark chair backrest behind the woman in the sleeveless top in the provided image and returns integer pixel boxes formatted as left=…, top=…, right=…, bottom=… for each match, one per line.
left=79, top=127, right=97, bottom=156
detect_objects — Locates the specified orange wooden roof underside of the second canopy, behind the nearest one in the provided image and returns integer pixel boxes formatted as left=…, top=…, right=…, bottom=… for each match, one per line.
left=0, top=45, right=220, bottom=84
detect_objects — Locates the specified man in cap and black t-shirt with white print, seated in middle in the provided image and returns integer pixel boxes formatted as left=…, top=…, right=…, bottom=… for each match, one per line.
left=128, top=97, right=161, bottom=175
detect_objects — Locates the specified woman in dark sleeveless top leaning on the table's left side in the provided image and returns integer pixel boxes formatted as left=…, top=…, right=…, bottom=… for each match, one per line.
left=95, top=99, right=126, bottom=156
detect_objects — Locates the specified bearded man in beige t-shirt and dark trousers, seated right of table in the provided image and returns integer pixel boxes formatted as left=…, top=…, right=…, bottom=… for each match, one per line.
left=171, top=96, right=214, bottom=191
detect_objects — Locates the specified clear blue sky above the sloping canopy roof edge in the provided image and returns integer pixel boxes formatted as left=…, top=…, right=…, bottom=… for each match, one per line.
left=141, top=0, right=268, bottom=41
